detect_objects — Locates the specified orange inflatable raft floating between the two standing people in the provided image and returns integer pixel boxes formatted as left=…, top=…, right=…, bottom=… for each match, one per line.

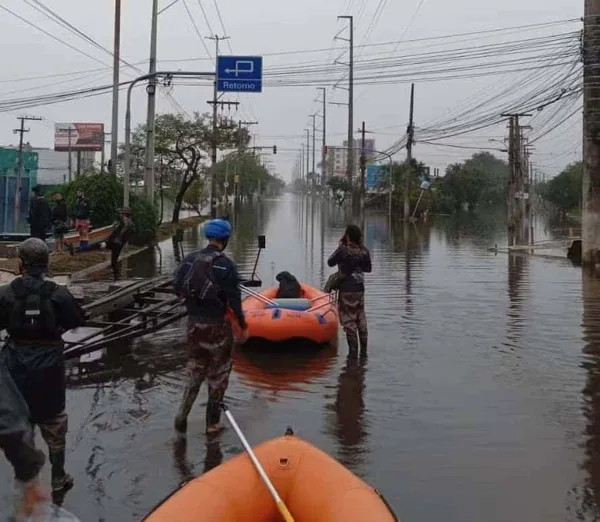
left=242, top=284, right=338, bottom=344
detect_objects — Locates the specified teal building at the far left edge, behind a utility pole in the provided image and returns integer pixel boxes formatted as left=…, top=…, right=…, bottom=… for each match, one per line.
left=0, top=147, right=38, bottom=232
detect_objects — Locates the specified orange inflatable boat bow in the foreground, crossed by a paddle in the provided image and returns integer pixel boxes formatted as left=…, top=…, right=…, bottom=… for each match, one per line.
left=144, top=435, right=398, bottom=522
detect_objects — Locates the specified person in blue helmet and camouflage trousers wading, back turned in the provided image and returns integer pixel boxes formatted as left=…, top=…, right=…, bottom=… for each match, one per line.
left=173, top=219, right=248, bottom=434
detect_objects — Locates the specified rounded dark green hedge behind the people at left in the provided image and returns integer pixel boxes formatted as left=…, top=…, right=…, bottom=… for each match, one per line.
left=54, top=173, right=158, bottom=245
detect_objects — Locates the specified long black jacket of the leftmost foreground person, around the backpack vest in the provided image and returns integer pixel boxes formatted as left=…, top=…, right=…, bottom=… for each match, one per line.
left=0, top=276, right=85, bottom=423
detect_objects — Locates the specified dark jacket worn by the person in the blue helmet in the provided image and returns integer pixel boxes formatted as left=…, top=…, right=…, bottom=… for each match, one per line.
left=173, top=245, right=246, bottom=328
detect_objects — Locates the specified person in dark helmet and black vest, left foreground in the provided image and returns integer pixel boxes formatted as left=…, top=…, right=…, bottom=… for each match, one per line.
left=0, top=238, right=85, bottom=498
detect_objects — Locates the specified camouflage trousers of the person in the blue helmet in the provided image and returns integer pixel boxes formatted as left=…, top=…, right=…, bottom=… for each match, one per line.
left=177, top=320, right=234, bottom=427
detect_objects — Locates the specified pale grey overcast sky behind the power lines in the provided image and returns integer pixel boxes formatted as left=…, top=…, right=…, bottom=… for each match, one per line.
left=0, top=0, right=583, bottom=179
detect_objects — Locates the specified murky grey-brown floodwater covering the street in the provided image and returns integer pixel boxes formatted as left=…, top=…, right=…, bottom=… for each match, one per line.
left=0, top=196, right=600, bottom=522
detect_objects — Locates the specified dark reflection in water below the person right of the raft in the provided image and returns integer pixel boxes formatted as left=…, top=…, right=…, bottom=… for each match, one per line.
left=331, top=351, right=369, bottom=475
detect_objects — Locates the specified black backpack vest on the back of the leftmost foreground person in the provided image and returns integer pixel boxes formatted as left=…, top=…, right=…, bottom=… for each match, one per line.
left=7, top=279, right=62, bottom=342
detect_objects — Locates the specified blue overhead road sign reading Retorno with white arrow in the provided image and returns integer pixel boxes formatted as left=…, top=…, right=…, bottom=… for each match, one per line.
left=217, top=56, right=262, bottom=92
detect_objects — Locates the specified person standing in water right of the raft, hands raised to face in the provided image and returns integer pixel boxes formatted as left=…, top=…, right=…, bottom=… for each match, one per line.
left=327, top=225, right=371, bottom=351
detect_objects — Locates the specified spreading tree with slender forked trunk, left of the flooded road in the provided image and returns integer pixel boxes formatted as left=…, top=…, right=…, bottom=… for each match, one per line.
left=131, top=113, right=241, bottom=223
